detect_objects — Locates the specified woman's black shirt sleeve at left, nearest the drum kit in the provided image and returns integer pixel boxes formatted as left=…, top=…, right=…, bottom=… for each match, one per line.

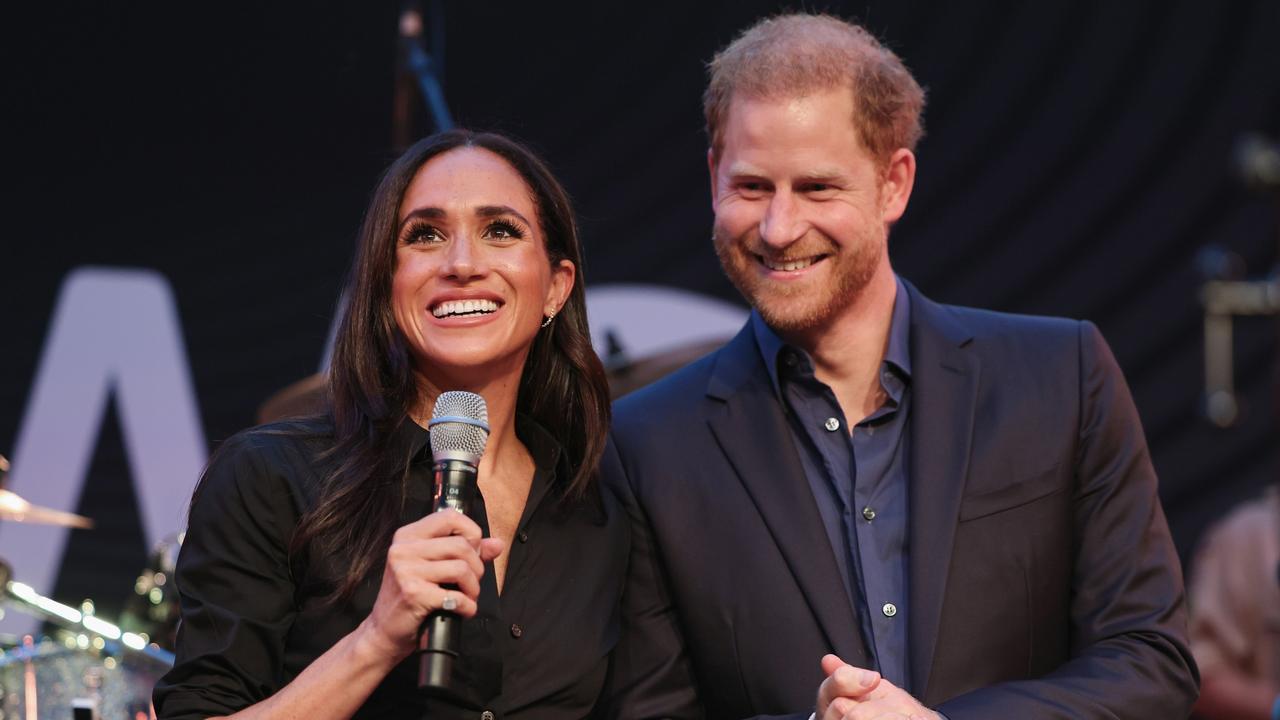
left=154, top=434, right=297, bottom=719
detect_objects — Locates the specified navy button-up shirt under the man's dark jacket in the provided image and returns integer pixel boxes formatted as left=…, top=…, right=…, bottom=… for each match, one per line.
left=751, top=274, right=911, bottom=687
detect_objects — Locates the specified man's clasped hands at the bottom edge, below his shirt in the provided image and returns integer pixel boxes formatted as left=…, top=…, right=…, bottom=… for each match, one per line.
left=814, top=655, right=941, bottom=720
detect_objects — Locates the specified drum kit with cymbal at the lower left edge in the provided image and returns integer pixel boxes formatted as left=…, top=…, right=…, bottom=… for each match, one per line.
left=0, top=455, right=180, bottom=720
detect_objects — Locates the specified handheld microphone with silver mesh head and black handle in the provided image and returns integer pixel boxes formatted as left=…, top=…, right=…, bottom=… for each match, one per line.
left=417, top=391, right=489, bottom=698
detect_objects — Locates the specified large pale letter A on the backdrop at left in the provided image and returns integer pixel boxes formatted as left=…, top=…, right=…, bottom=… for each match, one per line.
left=0, top=268, right=207, bottom=633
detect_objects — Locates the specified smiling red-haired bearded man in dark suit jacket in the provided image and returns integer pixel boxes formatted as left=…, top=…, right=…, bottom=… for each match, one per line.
left=603, top=15, right=1198, bottom=720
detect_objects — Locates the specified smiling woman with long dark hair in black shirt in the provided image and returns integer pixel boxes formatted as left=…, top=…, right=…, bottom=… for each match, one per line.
left=155, top=131, right=616, bottom=720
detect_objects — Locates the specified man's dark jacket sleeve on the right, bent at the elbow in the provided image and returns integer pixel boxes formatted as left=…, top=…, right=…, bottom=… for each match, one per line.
left=937, top=323, right=1199, bottom=720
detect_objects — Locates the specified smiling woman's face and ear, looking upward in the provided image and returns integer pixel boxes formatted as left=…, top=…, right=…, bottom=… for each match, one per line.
left=392, top=147, right=575, bottom=389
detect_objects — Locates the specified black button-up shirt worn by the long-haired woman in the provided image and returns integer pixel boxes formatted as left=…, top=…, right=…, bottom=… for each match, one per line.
left=155, top=418, right=628, bottom=720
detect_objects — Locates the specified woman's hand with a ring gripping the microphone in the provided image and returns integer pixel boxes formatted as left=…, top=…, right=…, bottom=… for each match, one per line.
left=357, top=510, right=506, bottom=661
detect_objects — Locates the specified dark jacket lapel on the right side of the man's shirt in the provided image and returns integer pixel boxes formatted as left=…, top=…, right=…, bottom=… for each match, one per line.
left=908, top=286, right=980, bottom=697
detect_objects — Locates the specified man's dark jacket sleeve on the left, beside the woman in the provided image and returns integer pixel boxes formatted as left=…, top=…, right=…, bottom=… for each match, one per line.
left=600, top=437, right=704, bottom=720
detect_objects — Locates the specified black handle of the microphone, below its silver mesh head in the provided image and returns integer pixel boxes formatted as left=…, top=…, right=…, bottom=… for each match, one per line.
left=417, top=457, right=477, bottom=700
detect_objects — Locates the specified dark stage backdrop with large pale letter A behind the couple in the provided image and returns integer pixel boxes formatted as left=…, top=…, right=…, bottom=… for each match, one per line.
left=0, top=0, right=1280, bottom=627
